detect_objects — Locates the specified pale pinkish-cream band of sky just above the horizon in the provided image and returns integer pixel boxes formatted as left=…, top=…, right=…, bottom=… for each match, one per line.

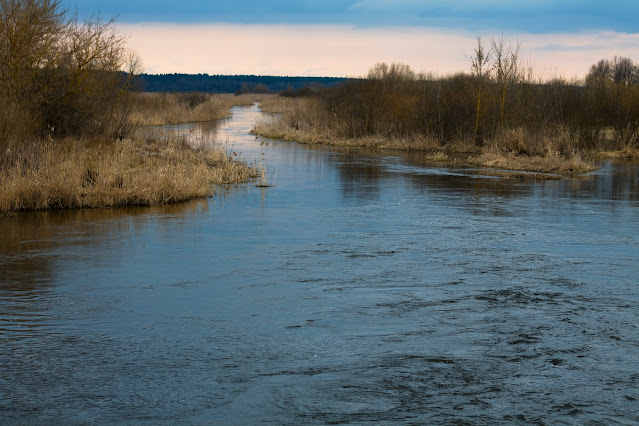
left=118, top=23, right=639, bottom=79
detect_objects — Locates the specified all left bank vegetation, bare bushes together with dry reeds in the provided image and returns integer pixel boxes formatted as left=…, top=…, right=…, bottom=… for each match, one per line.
left=0, top=0, right=257, bottom=215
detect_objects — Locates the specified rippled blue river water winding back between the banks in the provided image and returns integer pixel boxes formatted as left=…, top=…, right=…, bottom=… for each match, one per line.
left=0, top=107, right=639, bottom=424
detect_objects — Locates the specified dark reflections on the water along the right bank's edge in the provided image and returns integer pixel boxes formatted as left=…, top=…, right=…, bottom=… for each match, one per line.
left=333, top=145, right=639, bottom=216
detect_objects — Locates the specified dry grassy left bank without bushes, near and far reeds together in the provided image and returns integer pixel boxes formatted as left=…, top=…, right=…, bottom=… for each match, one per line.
left=0, top=93, right=286, bottom=215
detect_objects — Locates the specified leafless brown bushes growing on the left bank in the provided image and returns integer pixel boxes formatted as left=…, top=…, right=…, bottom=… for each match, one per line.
left=0, top=0, right=139, bottom=147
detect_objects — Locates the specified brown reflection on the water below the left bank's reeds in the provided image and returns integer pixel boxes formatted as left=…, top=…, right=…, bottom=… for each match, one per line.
left=0, top=200, right=209, bottom=338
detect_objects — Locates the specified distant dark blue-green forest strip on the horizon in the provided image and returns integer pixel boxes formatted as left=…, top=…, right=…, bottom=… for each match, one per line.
left=132, top=74, right=346, bottom=94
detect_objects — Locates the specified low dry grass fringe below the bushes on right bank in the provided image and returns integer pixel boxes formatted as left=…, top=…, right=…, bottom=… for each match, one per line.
left=253, top=98, right=608, bottom=178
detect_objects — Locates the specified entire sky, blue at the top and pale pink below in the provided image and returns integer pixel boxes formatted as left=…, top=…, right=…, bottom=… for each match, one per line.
left=63, top=0, right=639, bottom=78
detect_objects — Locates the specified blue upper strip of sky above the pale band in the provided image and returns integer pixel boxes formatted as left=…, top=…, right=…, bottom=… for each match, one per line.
left=66, top=0, right=639, bottom=33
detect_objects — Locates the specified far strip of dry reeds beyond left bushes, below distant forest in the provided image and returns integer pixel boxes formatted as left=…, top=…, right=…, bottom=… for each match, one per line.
left=129, top=93, right=265, bottom=126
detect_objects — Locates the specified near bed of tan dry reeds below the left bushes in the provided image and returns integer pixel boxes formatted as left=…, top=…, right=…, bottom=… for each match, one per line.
left=0, top=138, right=256, bottom=214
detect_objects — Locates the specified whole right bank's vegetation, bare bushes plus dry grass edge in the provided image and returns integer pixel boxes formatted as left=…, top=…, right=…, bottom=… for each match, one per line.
left=255, top=38, right=639, bottom=174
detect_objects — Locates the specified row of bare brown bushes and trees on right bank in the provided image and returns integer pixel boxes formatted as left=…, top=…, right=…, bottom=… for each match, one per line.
left=308, top=38, right=639, bottom=153
